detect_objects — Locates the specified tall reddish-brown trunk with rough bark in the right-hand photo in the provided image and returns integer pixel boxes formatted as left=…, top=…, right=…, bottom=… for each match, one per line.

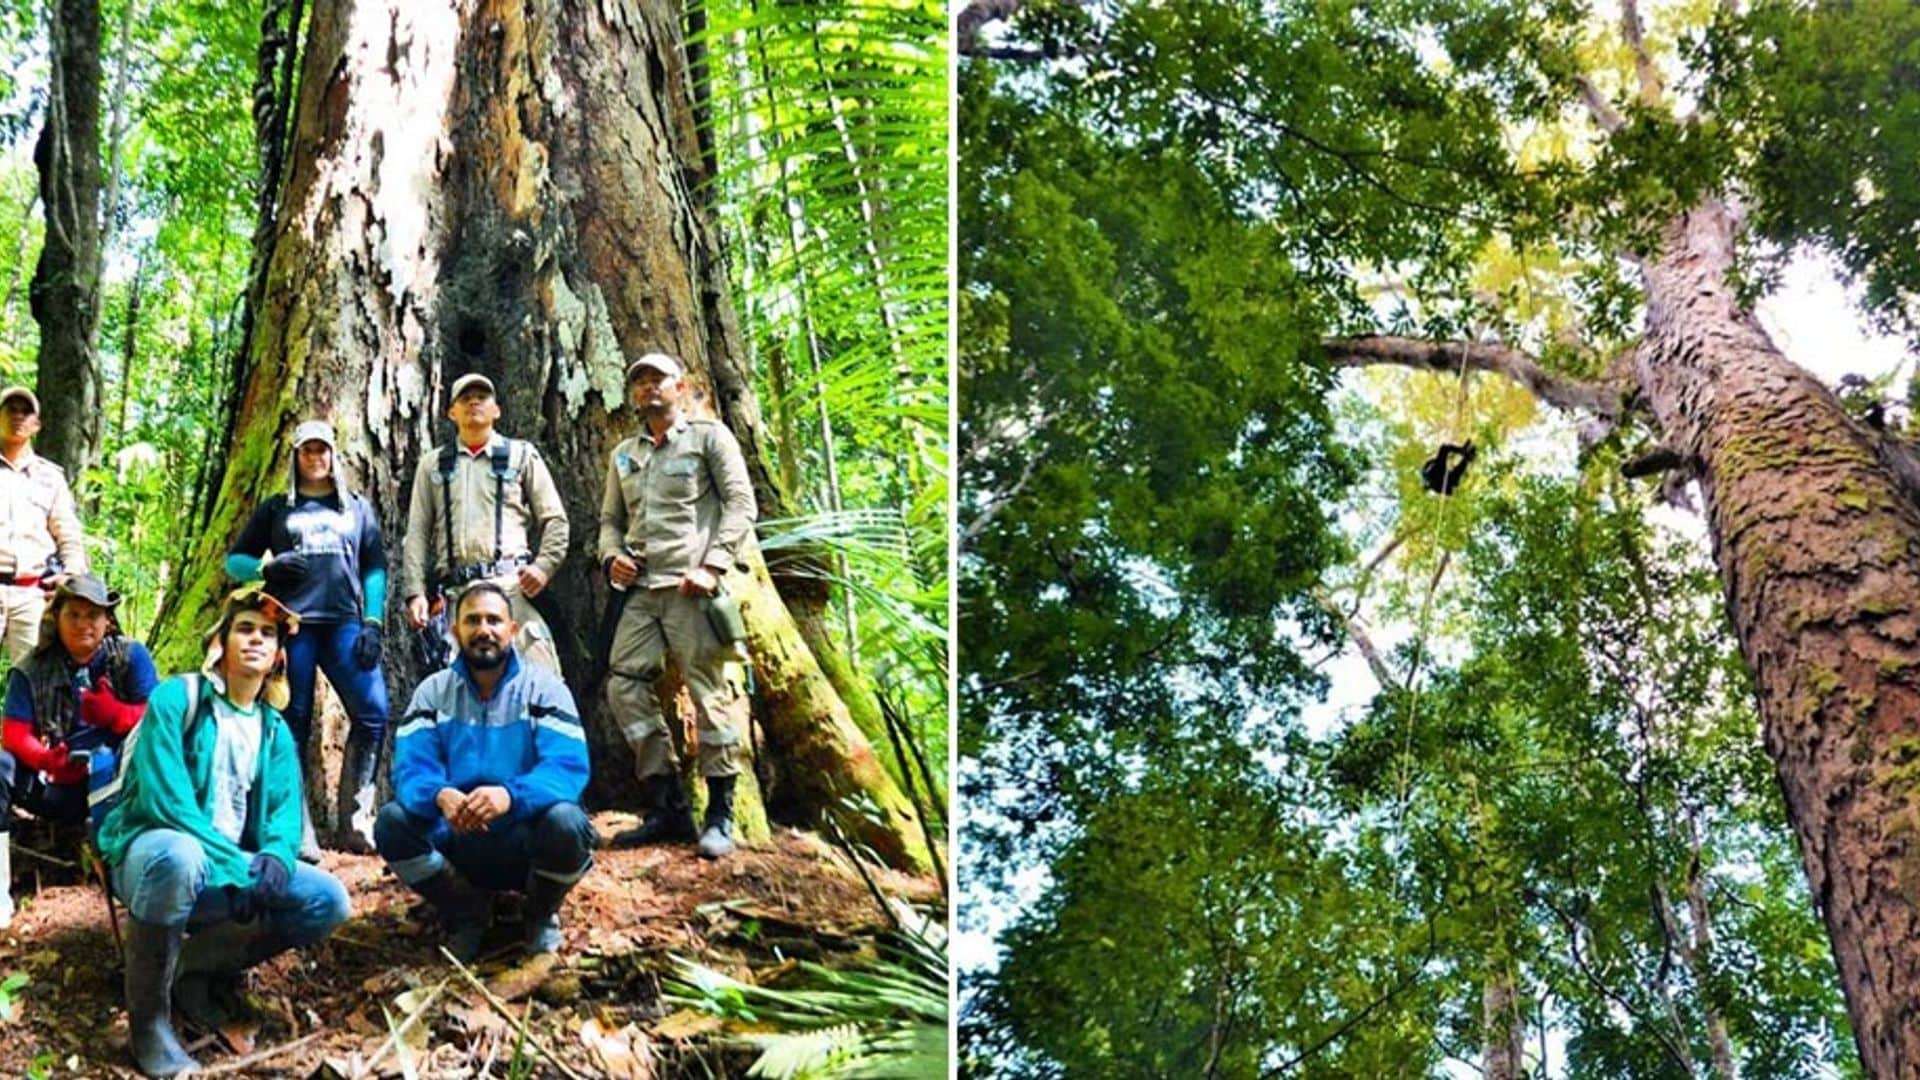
left=1638, top=202, right=1920, bottom=1078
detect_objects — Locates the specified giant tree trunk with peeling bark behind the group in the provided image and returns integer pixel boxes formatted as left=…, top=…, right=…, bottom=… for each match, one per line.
left=157, top=0, right=925, bottom=865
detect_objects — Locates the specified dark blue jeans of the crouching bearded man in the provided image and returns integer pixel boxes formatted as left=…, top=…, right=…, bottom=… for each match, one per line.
left=372, top=801, right=599, bottom=892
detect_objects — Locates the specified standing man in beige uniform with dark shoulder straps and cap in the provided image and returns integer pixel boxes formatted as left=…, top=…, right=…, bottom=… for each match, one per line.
left=399, top=373, right=568, bottom=675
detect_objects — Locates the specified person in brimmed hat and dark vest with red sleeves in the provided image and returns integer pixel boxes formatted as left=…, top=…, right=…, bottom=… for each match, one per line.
left=0, top=575, right=157, bottom=926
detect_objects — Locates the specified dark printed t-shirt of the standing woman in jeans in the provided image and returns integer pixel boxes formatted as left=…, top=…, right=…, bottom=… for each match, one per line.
left=234, top=494, right=386, bottom=623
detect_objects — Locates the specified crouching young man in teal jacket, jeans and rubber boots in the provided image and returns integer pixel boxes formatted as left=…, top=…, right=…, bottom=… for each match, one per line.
left=100, top=588, right=349, bottom=1076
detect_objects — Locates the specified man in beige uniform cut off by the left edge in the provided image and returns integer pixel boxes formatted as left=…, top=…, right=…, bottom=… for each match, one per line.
left=0, top=386, right=86, bottom=663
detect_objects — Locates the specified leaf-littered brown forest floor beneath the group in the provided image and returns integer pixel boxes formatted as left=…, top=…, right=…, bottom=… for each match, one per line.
left=0, top=813, right=941, bottom=1080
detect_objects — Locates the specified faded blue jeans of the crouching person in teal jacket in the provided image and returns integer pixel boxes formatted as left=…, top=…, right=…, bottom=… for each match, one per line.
left=113, top=828, right=353, bottom=937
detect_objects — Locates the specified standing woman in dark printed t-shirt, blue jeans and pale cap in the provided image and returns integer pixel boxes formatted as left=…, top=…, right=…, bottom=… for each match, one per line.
left=227, top=421, right=388, bottom=855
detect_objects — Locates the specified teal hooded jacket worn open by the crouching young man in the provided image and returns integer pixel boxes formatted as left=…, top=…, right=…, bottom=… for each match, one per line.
left=100, top=675, right=301, bottom=888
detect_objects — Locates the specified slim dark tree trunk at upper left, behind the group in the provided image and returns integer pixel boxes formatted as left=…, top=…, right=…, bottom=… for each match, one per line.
left=27, top=0, right=100, bottom=474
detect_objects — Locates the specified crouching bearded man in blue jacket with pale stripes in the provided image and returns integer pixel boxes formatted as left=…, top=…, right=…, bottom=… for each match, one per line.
left=372, top=580, right=597, bottom=961
